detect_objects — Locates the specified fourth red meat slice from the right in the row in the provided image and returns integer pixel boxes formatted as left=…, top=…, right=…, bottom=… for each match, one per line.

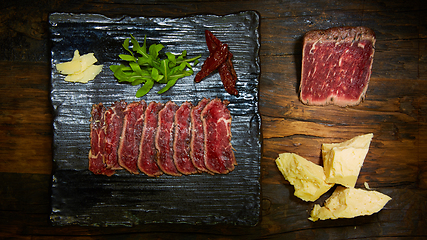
left=155, top=101, right=181, bottom=176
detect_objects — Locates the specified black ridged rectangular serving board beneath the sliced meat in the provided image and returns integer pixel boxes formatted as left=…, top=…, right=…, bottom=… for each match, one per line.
left=49, top=11, right=261, bottom=226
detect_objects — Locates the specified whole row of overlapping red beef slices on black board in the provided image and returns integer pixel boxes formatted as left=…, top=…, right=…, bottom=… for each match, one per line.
left=89, top=98, right=237, bottom=177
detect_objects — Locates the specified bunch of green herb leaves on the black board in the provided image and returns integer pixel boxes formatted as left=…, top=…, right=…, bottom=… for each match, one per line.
left=110, top=35, right=201, bottom=97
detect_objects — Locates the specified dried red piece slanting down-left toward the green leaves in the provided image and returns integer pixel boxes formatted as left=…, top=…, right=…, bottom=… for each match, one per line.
left=194, top=41, right=228, bottom=82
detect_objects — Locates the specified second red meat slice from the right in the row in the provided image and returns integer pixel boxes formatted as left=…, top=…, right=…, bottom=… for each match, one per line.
left=190, top=98, right=213, bottom=174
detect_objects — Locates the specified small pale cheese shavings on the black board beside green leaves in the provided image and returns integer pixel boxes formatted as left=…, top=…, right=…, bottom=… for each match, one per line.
left=56, top=50, right=103, bottom=83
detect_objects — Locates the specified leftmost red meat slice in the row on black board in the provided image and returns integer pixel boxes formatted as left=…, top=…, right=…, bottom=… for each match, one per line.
left=89, top=103, right=114, bottom=176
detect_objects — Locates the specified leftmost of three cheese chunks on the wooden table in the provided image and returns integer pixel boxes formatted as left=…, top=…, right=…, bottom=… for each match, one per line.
left=276, top=153, right=334, bottom=201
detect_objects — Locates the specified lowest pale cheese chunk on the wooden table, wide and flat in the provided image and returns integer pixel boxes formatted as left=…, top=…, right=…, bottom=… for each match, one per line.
left=309, top=186, right=391, bottom=222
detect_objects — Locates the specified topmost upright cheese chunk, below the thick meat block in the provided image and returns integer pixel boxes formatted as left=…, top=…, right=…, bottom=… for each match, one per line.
left=322, top=133, right=374, bottom=187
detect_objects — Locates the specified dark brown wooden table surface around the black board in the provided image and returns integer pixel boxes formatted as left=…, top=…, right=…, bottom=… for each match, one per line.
left=0, top=0, right=427, bottom=239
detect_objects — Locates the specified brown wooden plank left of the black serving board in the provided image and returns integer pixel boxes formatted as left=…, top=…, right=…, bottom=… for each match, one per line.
left=0, top=62, right=53, bottom=174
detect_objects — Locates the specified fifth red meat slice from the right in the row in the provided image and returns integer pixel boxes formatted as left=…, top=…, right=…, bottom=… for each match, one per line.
left=138, top=102, right=163, bottom=177
